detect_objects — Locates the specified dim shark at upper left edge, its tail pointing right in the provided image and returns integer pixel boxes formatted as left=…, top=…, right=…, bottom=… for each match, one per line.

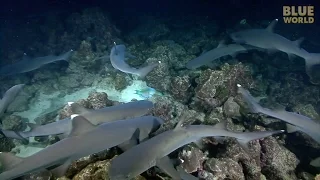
left=0, top=50, right=73, bottom=77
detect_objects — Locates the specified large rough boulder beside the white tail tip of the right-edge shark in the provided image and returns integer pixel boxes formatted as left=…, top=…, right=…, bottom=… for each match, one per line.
left=192, top=63, right=253, bottom=110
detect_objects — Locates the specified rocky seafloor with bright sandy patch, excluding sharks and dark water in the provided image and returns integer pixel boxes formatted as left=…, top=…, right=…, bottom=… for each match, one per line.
left=0, top=8, right=320, bottom=180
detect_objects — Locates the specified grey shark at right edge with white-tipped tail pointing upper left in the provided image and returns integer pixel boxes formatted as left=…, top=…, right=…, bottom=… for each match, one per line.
left=237, top=84, right=320, bottom=143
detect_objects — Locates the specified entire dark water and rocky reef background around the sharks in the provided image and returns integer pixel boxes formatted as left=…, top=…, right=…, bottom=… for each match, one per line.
left=0, top=0, right=320, bottom=180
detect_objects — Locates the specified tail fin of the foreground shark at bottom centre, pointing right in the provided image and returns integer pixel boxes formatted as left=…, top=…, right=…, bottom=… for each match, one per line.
left=237, top=130, right=284, bottom=153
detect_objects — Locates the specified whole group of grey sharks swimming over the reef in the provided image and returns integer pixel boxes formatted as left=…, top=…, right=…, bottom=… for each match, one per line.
left=0, top=19, right=320, bottom=180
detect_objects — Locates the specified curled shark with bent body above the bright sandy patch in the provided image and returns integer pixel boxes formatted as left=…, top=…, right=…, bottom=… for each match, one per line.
left=110, top=43, right=159, bottom=78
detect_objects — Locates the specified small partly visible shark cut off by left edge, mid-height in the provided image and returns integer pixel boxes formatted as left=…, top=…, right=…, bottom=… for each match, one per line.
left=0, top=84, right=25, bottom=117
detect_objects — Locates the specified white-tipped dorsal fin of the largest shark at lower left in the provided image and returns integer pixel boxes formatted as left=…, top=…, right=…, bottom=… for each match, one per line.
left=69, top=115, right=95, bottom=136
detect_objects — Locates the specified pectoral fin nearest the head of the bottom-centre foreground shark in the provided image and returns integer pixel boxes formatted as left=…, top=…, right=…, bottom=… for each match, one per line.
left=156, top=156, right=182, bottom=180
